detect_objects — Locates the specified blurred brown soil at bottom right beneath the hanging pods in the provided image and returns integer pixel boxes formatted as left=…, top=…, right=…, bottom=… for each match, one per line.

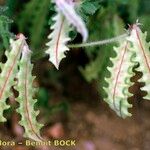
left=1, top=95, right=150, bottom=150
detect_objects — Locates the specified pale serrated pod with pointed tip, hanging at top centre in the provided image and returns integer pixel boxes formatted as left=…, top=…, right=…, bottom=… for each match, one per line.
left=46, top=11, right=70, bottom=69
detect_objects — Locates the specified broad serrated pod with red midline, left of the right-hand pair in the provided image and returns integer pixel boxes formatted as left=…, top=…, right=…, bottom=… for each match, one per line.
left=104, top=41, right=135, bottom=118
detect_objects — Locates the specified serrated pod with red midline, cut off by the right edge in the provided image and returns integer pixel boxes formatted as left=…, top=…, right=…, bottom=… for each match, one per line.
left=128, top=24, right=150, bottom=100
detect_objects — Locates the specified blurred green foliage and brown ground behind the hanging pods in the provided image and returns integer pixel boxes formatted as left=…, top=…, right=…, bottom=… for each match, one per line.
left=0, top=0, right=150, bottom=150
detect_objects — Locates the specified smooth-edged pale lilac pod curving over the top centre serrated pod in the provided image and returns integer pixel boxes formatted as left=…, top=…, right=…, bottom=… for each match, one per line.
left=55, top=0, right=88, bottom=41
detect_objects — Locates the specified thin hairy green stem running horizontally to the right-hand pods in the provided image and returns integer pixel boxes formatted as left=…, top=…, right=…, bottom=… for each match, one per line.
left=68, top=33, right=128, bottom=48
